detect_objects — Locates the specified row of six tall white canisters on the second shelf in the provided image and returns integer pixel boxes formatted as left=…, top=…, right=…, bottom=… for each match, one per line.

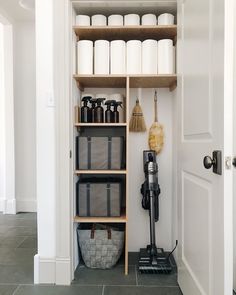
left=77, top=39, right=175, bottom=75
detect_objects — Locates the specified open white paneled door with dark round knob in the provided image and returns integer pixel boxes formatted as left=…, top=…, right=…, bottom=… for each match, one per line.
left=177, top=0, right=233, bottom=295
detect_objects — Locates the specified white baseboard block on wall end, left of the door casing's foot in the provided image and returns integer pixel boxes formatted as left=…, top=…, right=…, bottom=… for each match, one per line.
left=34, top=254, right=55, bottom=284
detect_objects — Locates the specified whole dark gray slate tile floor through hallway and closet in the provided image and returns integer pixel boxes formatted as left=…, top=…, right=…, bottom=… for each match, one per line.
left=0, top=213, right=182, bottom=295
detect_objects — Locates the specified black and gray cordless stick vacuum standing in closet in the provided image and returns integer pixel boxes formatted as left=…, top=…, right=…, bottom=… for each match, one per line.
left=139, top=150, right=172, bottom=273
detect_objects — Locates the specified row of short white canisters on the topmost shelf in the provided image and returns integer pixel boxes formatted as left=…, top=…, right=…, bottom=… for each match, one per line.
left=76, top=13, right=174, bottom=26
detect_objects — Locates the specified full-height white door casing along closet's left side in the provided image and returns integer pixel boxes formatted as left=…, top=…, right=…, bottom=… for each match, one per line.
left=53, top=0, right=73, bottom=285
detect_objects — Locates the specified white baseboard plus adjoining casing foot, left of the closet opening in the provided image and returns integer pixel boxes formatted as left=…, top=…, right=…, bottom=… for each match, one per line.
left=34, top=254, right=72, bottom=285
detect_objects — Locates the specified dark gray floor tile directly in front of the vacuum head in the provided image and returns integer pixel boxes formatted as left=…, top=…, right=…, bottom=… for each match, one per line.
left=137, top=271, right=178, bottom=287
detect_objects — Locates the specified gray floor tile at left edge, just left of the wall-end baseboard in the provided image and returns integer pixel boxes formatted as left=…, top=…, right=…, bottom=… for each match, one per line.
left=0, top=264, right=34, bottom=284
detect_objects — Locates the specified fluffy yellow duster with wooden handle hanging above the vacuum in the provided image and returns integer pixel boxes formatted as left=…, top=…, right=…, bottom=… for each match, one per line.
left=148, top=91, right=164, bottom=154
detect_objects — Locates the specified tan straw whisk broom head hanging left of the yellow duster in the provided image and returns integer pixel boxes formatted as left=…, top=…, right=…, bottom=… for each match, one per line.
left=129, top=99, right=147, bottom=132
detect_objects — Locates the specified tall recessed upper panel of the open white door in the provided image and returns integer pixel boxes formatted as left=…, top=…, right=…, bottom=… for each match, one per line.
left=183, top=0, right=211, bottom=139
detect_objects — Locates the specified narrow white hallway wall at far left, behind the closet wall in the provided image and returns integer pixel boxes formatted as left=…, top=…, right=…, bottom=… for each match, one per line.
left=14, top=21, right=36, bottom=212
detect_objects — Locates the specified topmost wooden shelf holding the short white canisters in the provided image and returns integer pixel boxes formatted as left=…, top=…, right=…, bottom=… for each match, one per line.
left=73, top=25, right=177, bottom=41
